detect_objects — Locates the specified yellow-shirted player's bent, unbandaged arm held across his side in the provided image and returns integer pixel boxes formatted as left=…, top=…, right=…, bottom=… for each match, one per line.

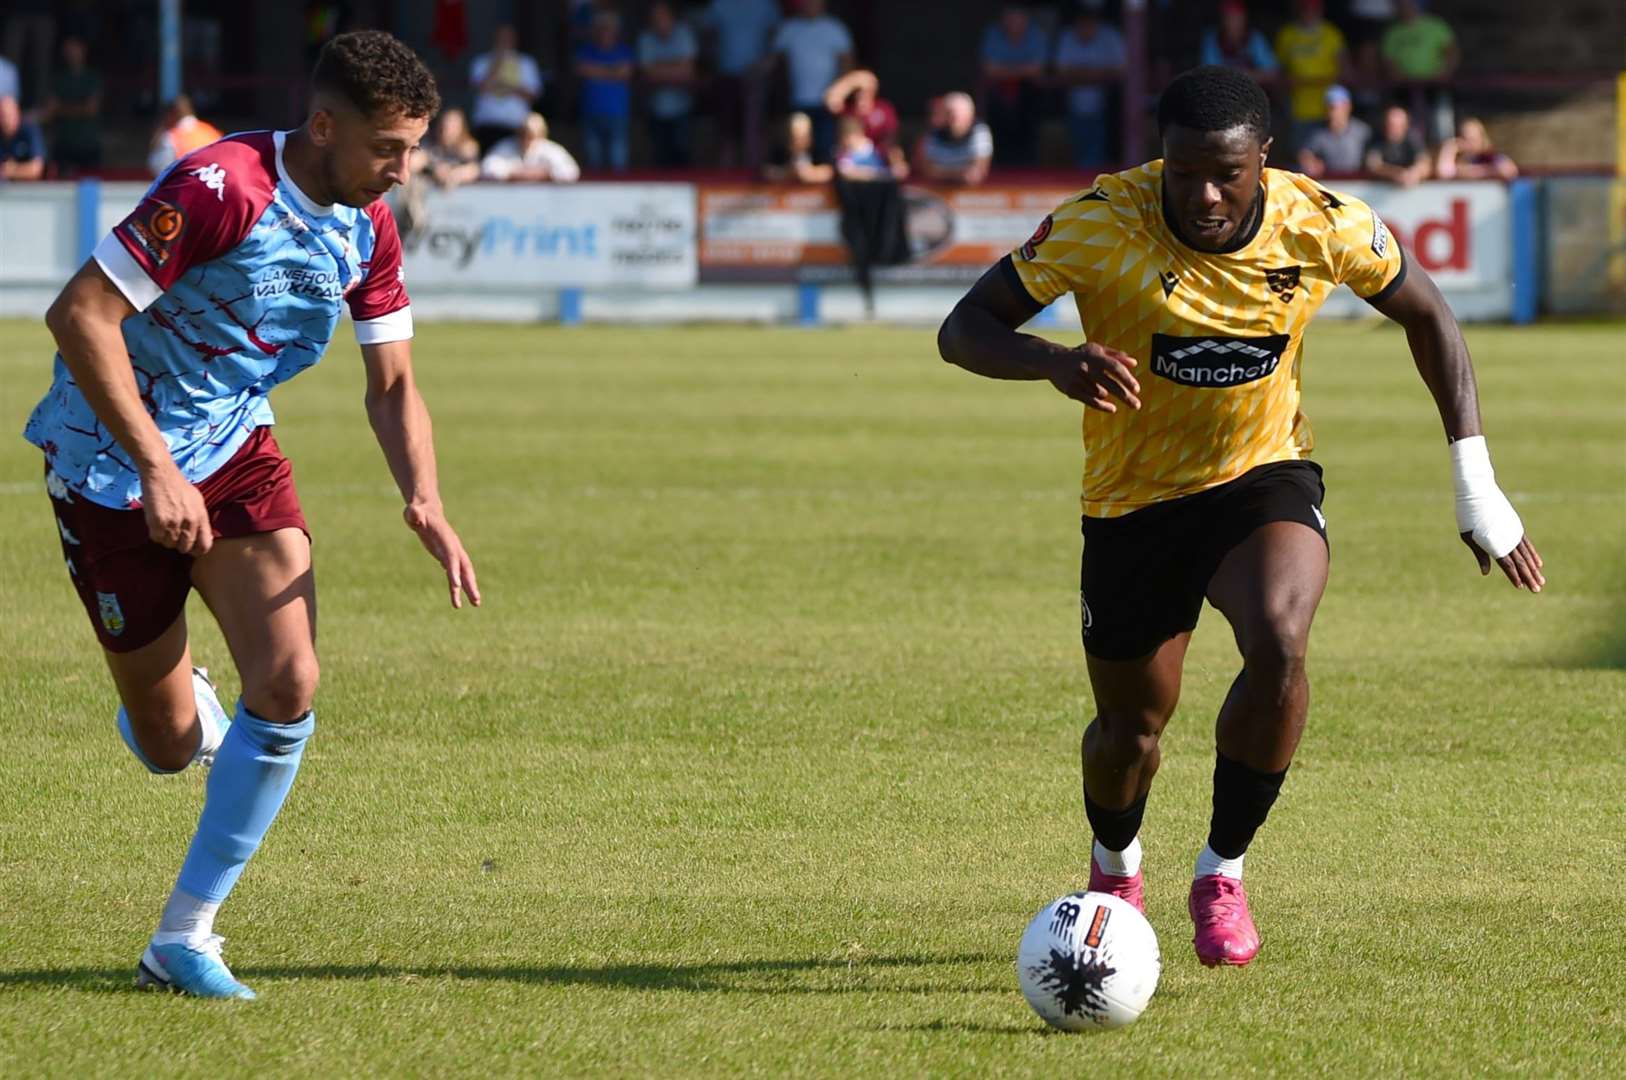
left=937, top=257, right=1140, bottom=413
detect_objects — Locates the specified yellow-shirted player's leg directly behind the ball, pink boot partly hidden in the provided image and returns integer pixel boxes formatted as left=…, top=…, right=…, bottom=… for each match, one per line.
left=1083, top=633, right=1192, bottom=911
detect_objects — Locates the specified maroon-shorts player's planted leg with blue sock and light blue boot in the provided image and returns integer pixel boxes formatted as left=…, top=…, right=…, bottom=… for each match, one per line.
left=140, top=529, right=317, bottom=997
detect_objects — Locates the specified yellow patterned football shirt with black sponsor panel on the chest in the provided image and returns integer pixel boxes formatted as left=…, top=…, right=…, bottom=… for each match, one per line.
left=1011, top=161, right=1405, bottom=517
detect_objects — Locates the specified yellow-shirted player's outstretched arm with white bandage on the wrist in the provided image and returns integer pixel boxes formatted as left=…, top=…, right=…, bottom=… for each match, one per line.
left=1377, top=263, right=1546, bottom=592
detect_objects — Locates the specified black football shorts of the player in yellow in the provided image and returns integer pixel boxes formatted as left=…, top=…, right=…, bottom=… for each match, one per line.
left=1078, top=460, right=1327, bottom=660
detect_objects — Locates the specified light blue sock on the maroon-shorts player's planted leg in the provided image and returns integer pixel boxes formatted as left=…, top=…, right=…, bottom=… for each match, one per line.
left=176, top=701, right=315, bottom=903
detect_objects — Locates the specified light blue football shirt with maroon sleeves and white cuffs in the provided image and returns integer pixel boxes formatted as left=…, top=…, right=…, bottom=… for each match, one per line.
left=23, top=132, right=411, bottom=507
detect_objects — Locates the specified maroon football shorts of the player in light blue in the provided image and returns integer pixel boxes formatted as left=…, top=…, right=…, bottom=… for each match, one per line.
left=46, top=428, right=311, bottom=652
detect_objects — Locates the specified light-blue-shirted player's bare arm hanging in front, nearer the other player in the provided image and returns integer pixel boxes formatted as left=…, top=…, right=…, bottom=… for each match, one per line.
left=361, top=340, right=480, bottom=608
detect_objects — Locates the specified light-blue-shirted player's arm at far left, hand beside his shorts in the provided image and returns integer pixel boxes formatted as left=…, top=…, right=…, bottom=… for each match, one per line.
left=46, top=259, right=213, bottom=555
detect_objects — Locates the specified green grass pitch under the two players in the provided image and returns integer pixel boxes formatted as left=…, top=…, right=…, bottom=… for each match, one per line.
left=0, top=322, right=1626, bottom=1077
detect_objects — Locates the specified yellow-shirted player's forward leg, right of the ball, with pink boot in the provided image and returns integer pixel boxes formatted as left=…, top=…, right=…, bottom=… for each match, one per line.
left=1189, top=522, right=1327, bottom=966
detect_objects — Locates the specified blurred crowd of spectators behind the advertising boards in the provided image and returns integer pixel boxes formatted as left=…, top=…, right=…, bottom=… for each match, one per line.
left=0, top=0, right=1515, bottom=187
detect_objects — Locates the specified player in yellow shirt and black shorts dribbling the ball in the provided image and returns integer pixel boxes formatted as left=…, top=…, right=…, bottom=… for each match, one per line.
left=938, top=67, right=1545, bottom=966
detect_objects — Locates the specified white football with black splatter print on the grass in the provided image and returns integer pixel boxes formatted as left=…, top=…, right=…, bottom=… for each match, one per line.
left=1016, top=893, right=1163, bottom=1031
